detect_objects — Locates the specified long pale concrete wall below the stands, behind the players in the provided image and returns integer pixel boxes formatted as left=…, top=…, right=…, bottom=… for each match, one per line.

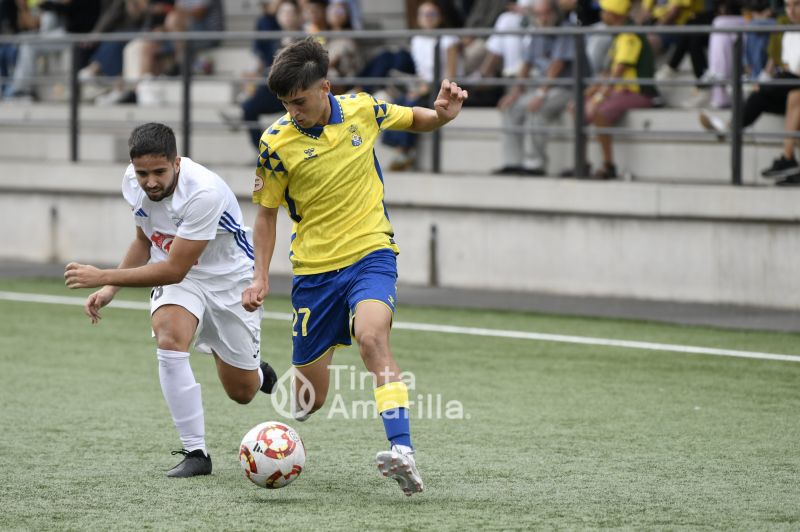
left=0, top=163, right=800, bottom=309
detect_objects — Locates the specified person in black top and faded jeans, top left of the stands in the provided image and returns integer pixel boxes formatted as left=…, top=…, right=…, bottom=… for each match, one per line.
left=6, top=0, right=101, bottom=100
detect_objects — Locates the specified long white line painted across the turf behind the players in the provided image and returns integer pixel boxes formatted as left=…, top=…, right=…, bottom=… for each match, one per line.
left=0, top=291, right=800, bottom=362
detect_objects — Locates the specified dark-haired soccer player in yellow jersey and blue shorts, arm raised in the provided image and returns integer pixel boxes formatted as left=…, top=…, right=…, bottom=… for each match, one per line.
left=242, top=39, right=467, bottom=495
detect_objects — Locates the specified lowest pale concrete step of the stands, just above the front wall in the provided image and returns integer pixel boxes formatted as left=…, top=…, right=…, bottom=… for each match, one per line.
left=0, top=124, right=779, bottom=185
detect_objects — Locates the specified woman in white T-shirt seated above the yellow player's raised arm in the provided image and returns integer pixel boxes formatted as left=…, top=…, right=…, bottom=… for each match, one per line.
left=383, top=1, right=463, bottom=171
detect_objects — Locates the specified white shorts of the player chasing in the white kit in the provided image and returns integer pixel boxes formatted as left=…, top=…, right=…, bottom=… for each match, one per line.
left=150, top=278, right=263, bottom=370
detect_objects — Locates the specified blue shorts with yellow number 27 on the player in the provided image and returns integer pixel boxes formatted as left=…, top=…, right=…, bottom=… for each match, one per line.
left=292, top=249, right=397, bottom=366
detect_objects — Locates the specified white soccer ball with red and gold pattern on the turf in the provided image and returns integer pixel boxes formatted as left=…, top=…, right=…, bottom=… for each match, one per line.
left=239, top=421, right=306, bottom=489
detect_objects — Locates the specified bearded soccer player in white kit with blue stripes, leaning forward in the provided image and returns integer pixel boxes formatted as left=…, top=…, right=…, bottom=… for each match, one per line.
left=64, top=123, right=277, bottom=477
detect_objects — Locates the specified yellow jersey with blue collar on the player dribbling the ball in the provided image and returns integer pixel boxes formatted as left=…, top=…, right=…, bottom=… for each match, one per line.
left=253, top=93, right=413, bottom=275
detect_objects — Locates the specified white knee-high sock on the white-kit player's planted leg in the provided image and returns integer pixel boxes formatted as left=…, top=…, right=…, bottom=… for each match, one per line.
left=156, top=349, right=208, bottom=454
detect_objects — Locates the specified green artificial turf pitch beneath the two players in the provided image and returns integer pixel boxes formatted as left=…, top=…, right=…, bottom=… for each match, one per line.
left=0, top=280, right=800, bottom=530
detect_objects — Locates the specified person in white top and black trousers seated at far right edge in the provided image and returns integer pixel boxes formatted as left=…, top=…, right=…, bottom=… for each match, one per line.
left=700, top=0, right=800, bottom=185
